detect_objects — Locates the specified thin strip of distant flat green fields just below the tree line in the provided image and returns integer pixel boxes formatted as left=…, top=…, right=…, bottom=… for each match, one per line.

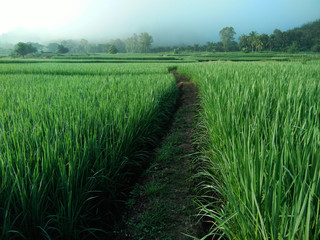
left=0, top=52, right=320, bottom=64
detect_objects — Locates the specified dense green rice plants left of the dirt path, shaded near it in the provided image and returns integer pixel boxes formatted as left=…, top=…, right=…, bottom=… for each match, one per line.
left=0, top=62, right=177, bottom=239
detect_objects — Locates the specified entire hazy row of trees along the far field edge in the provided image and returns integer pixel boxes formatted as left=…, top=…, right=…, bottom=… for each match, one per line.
left=8, top=20, right=320, bottom=57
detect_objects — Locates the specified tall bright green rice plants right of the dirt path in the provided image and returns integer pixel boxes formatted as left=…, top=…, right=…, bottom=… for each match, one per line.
left=178, top=62, right=320, bottom=240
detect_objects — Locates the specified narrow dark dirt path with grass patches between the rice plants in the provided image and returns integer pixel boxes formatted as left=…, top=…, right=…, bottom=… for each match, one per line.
left=115, top=71, right=201, bottom=240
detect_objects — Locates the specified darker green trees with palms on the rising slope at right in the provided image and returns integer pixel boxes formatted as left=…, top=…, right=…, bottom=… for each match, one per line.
left=179, top=20, right=320, bottom=53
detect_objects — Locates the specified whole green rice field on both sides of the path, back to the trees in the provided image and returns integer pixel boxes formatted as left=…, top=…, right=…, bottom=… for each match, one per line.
left=0, top=53, right=320, bottom=240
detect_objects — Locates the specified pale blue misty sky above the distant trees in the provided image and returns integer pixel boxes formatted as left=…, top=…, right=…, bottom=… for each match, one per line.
left=0, top=0, right=320, bottom=46
